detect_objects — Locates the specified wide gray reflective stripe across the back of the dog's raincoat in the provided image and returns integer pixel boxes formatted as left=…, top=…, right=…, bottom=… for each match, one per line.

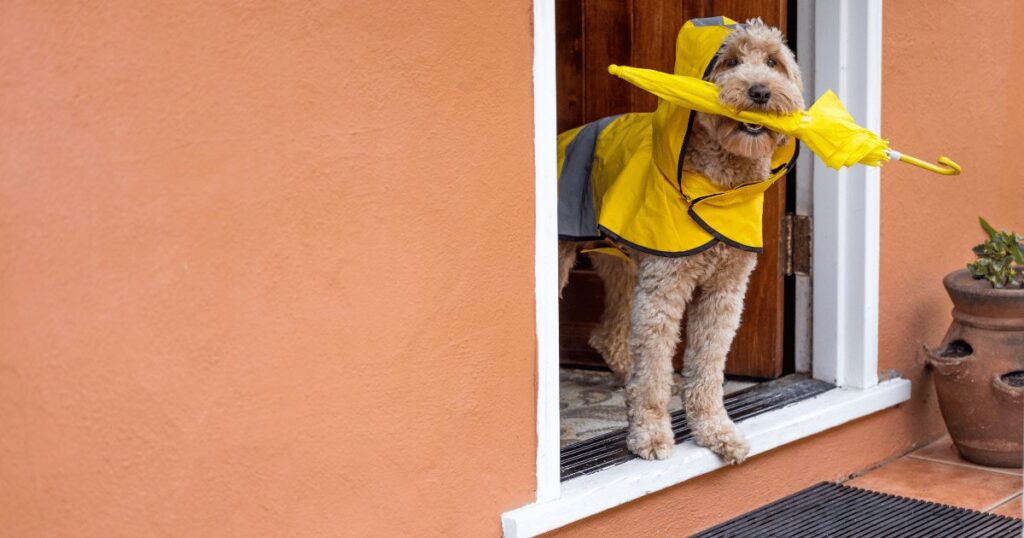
left=558, top=116, right=618, bottom=240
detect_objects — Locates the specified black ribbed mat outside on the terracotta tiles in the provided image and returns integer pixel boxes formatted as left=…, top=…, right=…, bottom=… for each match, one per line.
left=693, top=482, right=1021, bottom=538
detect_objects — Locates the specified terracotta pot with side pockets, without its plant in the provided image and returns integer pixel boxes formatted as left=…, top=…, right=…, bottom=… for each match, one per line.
left=926, top=270, right=1024, bottom=467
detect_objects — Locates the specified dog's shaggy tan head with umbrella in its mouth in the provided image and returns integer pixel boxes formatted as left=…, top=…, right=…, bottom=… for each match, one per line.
left=696, top=18, right=804, bottom=159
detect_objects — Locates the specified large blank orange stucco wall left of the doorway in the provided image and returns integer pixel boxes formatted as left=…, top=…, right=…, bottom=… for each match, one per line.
left=0, top=0, right=536, bottom=537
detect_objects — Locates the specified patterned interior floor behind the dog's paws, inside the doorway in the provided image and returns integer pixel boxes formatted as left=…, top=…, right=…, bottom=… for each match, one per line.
left=558, top=367, right=757, bottom=448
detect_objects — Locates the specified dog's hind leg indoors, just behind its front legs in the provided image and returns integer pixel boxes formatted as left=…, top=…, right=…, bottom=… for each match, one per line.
left=590, top=254, right=637, bottom=382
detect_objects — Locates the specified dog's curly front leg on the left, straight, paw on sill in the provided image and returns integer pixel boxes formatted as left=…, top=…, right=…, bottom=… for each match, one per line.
left=626, top=255, right=694, bottom=459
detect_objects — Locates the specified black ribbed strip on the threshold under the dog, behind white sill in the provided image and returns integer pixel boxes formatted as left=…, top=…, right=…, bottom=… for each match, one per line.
left=561, top=375, right=835, bottom=481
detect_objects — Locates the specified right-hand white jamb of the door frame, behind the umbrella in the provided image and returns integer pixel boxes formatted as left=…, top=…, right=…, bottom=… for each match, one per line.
left=812, top=0, right=882, bottom=388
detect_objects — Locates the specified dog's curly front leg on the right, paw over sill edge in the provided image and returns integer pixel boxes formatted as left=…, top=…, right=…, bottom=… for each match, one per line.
left=683, top=252, right=757, bottom=463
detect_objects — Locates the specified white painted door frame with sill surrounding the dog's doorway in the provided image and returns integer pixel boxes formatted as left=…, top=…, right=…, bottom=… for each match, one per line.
left=516, top=0, right=892, bottom=536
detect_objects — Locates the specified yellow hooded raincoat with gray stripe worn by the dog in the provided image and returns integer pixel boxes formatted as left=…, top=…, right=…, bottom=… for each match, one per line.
left=558, top=17, right=797, bottom=256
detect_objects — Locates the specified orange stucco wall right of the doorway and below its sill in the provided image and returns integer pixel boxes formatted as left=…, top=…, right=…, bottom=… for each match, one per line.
left=552, top=0, right=1024, bottom=536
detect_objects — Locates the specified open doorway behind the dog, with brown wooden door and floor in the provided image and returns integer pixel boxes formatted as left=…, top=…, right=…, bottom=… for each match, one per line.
left=556, top=0, right=820, bottom=452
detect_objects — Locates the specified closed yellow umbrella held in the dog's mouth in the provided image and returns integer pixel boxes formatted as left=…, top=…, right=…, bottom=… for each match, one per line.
left=608, top=66, right=961, bottom=175
